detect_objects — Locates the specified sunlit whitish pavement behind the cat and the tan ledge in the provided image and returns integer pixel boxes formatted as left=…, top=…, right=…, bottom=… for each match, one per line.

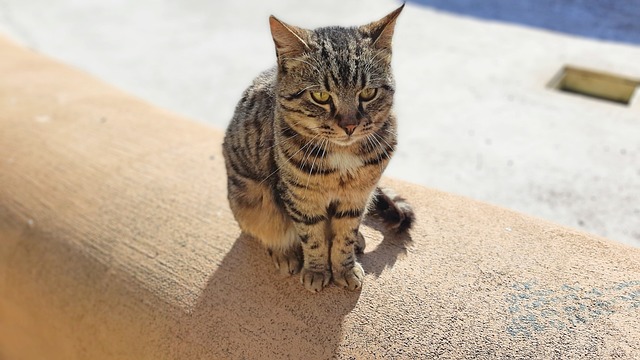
left=0, top=0, right=640, bottom=246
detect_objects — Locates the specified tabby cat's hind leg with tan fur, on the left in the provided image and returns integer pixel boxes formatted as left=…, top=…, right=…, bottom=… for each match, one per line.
left=228, top=177, right=302, bottom=275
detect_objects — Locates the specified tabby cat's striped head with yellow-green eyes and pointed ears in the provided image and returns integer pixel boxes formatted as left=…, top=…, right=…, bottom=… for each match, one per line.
left=269, top=5, right=404, bottom=146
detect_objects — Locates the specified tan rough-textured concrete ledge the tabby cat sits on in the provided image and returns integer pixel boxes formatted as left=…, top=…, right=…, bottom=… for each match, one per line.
left=0, top=34, right=640, bottom=360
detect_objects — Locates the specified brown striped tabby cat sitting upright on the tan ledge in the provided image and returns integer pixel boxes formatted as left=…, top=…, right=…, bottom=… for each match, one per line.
left=223, top=5, right=415, bottom=292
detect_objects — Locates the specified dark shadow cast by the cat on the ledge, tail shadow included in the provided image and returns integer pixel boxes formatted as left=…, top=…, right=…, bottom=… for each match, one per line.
left=176, top=215, right=411, bottom=359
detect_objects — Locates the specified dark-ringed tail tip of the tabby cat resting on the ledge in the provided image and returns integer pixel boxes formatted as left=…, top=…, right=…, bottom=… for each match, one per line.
left=370, top=187, right=416, bottom=233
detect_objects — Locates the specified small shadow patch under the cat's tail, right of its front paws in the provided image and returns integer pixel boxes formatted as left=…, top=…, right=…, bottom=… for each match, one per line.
left=358, top=216, right=413, bottom=277
